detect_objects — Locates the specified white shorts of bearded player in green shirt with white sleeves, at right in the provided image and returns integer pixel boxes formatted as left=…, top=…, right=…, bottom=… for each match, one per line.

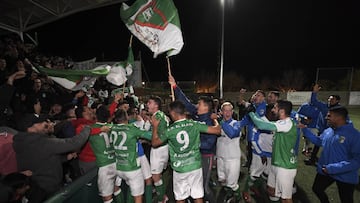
left=267, top=166, right=296, bottom=199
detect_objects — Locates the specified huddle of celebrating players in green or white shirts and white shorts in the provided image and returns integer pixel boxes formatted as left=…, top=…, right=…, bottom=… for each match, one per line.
left=89, top=75, right=360, bottom=203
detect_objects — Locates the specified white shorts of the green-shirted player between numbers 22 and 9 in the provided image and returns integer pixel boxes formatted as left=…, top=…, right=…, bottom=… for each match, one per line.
left=150, top=144, right=169, bottom=174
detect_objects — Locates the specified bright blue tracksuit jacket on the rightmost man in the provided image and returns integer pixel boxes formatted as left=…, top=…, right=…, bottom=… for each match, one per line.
left=303, top=123, right=360, bottom=184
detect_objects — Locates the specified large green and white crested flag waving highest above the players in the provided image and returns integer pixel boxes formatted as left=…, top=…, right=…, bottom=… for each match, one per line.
left=120, top=0, right=184, bottom=58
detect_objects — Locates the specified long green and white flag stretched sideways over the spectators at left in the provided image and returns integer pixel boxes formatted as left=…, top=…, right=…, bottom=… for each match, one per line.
left=35, top=64, right=111, bottom=91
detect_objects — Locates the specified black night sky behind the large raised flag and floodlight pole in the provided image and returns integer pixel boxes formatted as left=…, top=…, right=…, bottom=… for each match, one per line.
left=29, top=0, right=360, bottom=81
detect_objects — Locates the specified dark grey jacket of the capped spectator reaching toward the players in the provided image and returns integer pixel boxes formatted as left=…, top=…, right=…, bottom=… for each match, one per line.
left=13, top=127, right=90, bottom=195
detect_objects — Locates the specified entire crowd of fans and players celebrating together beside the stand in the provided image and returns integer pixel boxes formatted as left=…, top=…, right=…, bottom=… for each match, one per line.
left=0, top=35, right=360, bottom=203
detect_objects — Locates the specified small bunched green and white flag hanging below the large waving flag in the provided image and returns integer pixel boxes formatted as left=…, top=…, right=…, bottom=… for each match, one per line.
left=106, top=45, right=135, bottom=86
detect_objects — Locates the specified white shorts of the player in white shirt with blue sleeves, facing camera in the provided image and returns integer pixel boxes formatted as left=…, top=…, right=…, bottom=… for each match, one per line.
left=216, top=157, right=241, bottom=189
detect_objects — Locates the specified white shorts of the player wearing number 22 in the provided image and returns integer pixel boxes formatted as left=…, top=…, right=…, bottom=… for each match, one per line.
left=116, top=168, right=145, bottom=196
